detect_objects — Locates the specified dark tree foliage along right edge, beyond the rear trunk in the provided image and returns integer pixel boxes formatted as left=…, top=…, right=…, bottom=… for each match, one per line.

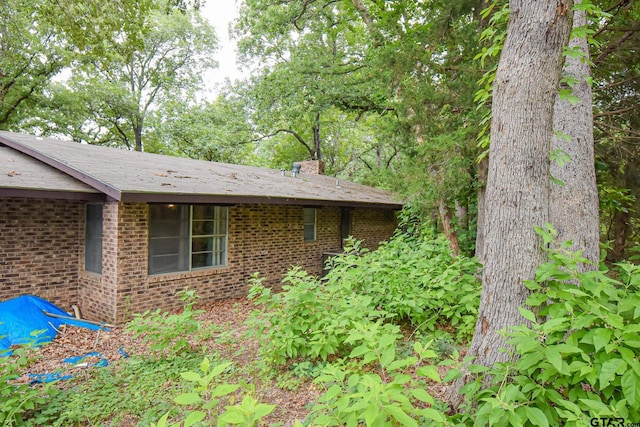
left=592, top=0, right=640, bottom=262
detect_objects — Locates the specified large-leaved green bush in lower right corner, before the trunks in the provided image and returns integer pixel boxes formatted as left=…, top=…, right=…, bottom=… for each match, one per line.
left=460, top=230, right=640, bottom=426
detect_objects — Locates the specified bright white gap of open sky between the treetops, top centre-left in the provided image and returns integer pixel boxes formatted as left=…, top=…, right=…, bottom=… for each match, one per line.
left=201, top=0, right=242, bottom=93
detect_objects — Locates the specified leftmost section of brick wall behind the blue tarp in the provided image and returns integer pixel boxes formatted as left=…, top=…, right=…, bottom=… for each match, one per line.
left=0, top=198, right=84, bottom=310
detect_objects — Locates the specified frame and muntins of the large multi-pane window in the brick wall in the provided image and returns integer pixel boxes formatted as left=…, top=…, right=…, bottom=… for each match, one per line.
left=147, top=203, right=229, bottom=276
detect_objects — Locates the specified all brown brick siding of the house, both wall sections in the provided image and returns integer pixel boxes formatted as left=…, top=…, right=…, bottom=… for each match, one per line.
left=0, top=199, right=395, bottom=322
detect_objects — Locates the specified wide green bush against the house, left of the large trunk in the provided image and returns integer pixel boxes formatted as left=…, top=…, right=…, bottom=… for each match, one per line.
left=249, top=227, right=480, bottom=365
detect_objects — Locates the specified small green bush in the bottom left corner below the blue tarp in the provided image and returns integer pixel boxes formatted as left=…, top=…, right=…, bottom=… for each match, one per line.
left=0, top=345, right=56, bottom=426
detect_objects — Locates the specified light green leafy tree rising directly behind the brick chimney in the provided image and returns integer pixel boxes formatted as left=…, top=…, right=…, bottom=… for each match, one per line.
left=238, top=0, right=389, bottom=164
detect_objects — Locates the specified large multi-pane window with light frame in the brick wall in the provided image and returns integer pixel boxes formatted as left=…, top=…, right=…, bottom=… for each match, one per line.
left=149, top=205, right=227, bottom=274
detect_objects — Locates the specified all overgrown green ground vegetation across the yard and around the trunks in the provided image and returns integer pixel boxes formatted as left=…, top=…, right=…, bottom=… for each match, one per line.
left=5, top=229, right=640, bottom=427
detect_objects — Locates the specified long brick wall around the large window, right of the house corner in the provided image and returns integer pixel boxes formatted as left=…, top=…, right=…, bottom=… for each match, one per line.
left=103, top=203, right=394, bottom=322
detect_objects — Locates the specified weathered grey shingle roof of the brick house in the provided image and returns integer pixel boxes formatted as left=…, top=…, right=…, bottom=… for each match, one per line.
left=0, top=131, right=402, bottom=209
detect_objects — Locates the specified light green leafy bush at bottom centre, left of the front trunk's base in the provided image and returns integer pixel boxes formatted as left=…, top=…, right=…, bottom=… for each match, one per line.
left=309, top=333, right=450, bottom=427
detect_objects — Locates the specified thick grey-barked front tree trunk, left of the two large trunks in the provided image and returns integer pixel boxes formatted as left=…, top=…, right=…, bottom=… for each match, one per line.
left=449, top=0, right=573, bottom=405
